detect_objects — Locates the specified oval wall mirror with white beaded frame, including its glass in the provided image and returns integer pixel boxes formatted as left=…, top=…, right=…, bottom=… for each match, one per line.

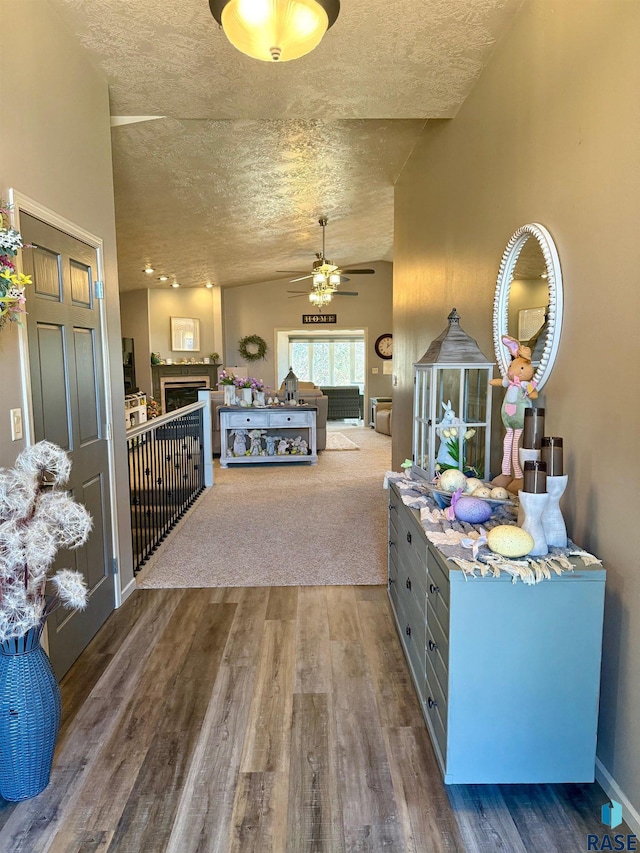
left=493, top=224, right=562, bottom=390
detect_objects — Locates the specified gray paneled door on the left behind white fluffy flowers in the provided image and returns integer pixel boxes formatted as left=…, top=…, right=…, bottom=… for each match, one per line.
left=20, top=213, right=114, bottom=678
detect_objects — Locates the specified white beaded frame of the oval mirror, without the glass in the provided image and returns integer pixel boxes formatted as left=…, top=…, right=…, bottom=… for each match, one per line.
left=493, top=223, right=562, bottom=390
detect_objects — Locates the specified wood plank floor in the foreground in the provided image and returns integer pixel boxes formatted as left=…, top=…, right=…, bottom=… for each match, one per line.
left=0, top=587, right=624, bottom=853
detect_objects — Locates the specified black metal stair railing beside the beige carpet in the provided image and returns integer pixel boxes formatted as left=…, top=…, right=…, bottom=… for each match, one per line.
left=127, top=403, right=205, bottom=572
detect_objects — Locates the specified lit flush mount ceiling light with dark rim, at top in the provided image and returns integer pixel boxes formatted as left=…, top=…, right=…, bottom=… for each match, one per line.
left=209, top=0, right=340, bottom=62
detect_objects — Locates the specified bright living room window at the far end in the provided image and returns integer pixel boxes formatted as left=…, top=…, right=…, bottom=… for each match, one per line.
left=289, top=337, right=364, bottom=394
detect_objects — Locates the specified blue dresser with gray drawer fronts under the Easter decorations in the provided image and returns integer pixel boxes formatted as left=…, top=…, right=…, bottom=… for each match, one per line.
left=388, top=484, right=606, bottom=784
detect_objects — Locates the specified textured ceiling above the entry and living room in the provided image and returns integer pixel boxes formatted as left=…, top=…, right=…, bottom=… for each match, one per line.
left=51, top=0, right=522, bottom=290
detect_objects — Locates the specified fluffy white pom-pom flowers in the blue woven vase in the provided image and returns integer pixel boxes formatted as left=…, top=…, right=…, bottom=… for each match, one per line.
left=0, top=441, right=92, bottom=642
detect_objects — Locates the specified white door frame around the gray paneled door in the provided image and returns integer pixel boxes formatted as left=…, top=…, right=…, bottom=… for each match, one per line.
left=8, top=187, right=122, bottom=624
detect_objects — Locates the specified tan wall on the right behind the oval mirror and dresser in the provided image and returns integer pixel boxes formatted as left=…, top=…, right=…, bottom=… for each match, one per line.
left=393, top=0, right=640, bottom=819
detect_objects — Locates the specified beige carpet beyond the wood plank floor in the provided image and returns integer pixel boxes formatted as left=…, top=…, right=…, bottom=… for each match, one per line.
left=138, top=427, right=391, bottom=588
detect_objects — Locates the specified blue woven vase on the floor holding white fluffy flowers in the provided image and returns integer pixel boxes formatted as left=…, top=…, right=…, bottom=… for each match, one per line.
left=0, top=625, right=61, bottom=802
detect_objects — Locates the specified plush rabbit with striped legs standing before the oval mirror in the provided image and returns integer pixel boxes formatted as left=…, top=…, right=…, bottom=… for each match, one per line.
left=489, top=335, right=538, bottom=487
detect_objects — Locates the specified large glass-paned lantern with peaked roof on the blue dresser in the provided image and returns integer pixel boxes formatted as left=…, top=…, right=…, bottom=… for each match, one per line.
left=412, top=308, right=494, bottom=481
